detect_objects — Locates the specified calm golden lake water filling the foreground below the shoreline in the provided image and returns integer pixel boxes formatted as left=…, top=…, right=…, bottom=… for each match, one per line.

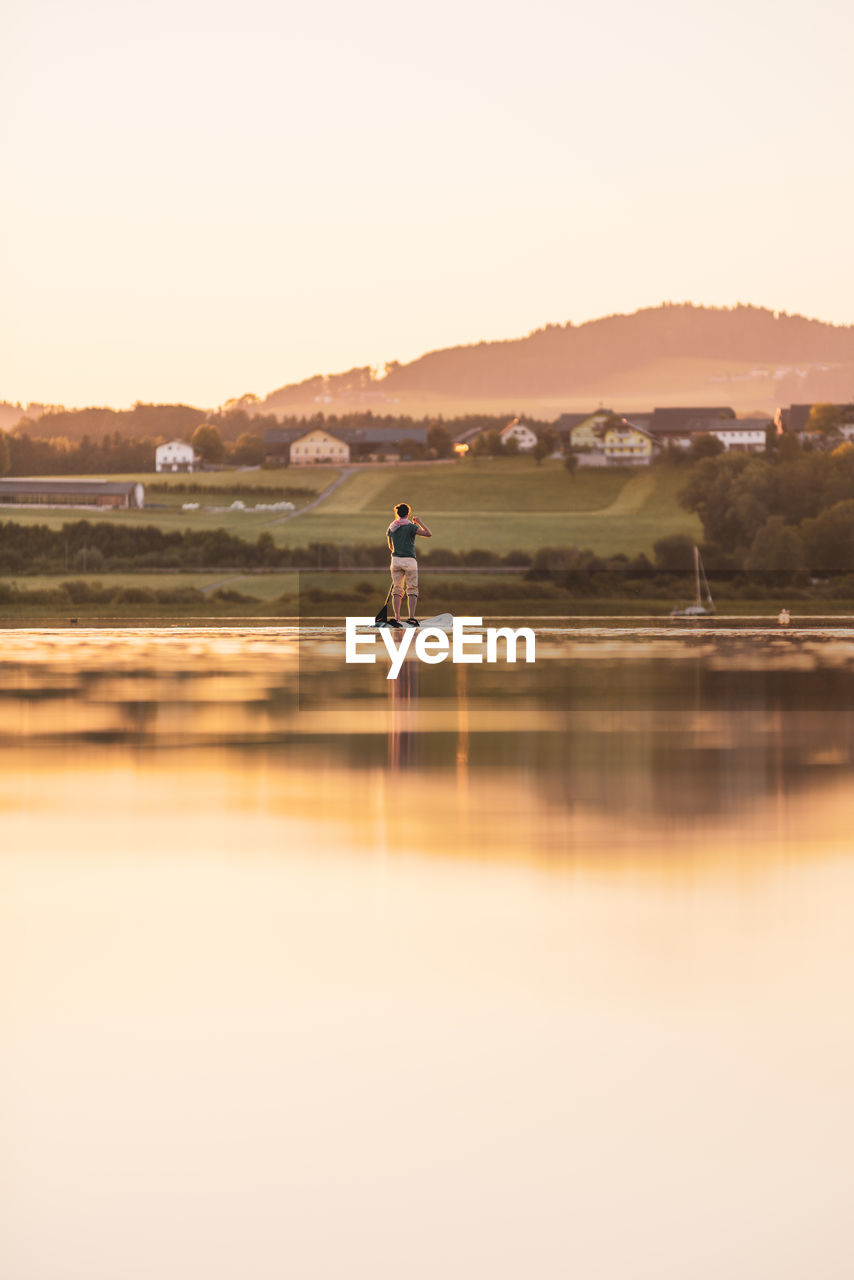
left=0, top=623, right=854, bottom=1280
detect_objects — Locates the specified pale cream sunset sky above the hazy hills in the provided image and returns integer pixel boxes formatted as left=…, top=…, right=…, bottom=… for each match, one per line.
left=0, top=0, right=854, bottom=407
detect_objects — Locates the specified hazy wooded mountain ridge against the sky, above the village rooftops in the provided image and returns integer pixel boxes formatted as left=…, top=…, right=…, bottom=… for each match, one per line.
left=254, top=302, right=854, bottom=413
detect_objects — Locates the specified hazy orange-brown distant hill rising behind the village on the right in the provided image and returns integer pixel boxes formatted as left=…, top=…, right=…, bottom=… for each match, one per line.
left=257, top=303, right=854, bottom=416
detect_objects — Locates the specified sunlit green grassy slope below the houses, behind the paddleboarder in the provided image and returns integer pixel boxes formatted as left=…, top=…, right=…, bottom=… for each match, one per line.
left=0, top=458, right=700, bottom=556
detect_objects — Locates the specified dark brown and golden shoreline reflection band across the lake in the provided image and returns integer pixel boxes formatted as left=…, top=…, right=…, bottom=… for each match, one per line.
left=15, top=645, right=854, bottom=819
